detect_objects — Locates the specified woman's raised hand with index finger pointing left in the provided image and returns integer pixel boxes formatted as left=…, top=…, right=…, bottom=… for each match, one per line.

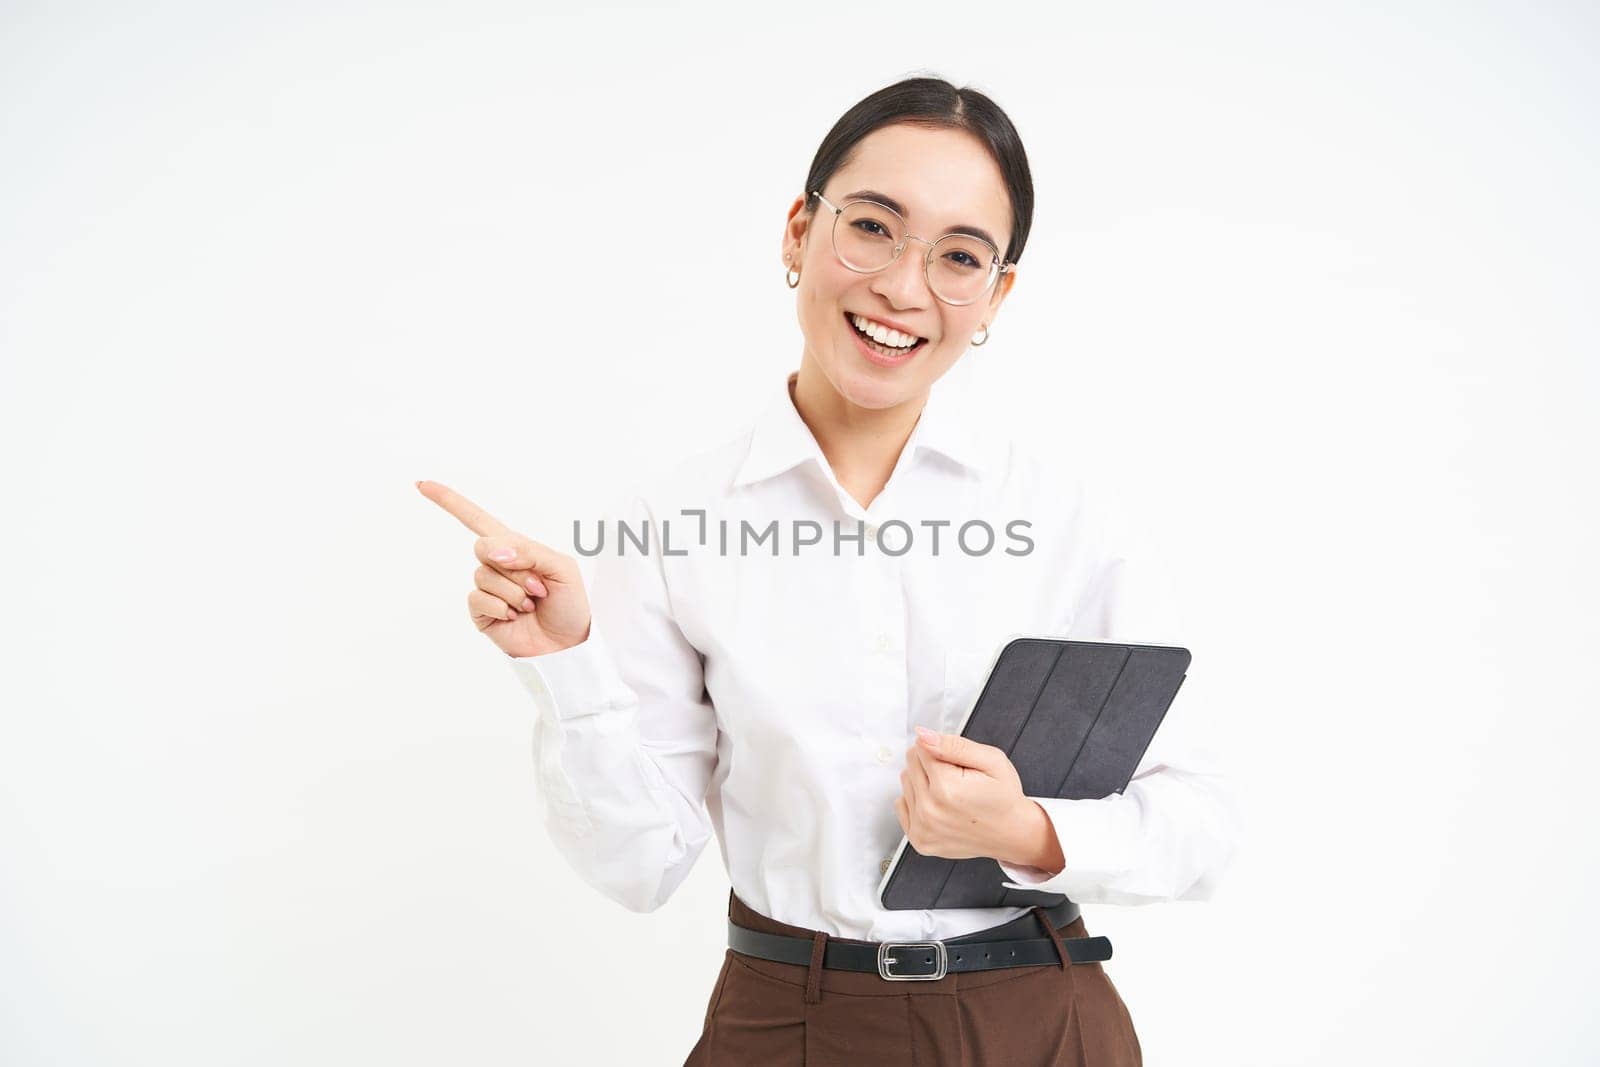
left=416, top=480, right=589, bottom=657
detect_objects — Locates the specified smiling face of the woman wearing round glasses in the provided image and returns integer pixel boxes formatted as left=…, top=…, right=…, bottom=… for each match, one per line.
left=782, top=125, right=1016, bottom=408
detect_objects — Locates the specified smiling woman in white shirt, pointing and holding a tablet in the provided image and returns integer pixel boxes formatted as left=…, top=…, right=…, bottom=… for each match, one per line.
left=419, top=78, right=1234, bottom=1067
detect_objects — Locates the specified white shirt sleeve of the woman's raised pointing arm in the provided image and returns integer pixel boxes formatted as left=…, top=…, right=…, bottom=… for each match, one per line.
left=510, top=498, right=717, bottom=912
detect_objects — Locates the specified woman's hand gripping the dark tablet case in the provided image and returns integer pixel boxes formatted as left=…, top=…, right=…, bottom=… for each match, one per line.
left=894, top=728, right=1038, bottom=862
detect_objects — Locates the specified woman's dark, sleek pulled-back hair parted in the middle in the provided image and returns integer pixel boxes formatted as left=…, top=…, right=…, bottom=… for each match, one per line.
left=803, top=77, right=1034, bottom=262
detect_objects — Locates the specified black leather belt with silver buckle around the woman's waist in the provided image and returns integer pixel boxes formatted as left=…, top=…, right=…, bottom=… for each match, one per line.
left=728, top=901, right=1110, bottom=982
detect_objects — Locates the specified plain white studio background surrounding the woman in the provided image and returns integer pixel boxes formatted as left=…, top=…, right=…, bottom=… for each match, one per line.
left=0, top=3, right=1600, bottom=1067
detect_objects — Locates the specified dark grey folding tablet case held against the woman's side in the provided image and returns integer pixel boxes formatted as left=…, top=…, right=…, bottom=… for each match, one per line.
left=882, top=637, right=1190, bottom=910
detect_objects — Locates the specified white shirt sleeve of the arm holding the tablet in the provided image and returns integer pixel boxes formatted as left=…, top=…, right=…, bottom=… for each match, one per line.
left=1000, top=489, right=1242, bottom=904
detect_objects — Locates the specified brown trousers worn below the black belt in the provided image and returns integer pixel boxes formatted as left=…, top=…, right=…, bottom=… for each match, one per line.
left=683, top=891, right=1144, bottom=1067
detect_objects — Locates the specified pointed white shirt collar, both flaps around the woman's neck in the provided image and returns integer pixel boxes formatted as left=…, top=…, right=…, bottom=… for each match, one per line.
left=733, top=360, right=989, bottom=486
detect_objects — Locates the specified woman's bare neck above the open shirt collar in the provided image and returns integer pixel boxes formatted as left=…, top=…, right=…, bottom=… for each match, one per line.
left=789, top=360, right=928, bottom=507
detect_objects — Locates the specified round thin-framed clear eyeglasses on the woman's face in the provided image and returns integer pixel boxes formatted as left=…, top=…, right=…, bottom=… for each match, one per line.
left=811, top=190, right=1016, bottom=307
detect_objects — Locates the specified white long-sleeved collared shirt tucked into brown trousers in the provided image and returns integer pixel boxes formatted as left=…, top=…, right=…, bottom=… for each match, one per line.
left=510, top=363, right=1237, bottom=941
